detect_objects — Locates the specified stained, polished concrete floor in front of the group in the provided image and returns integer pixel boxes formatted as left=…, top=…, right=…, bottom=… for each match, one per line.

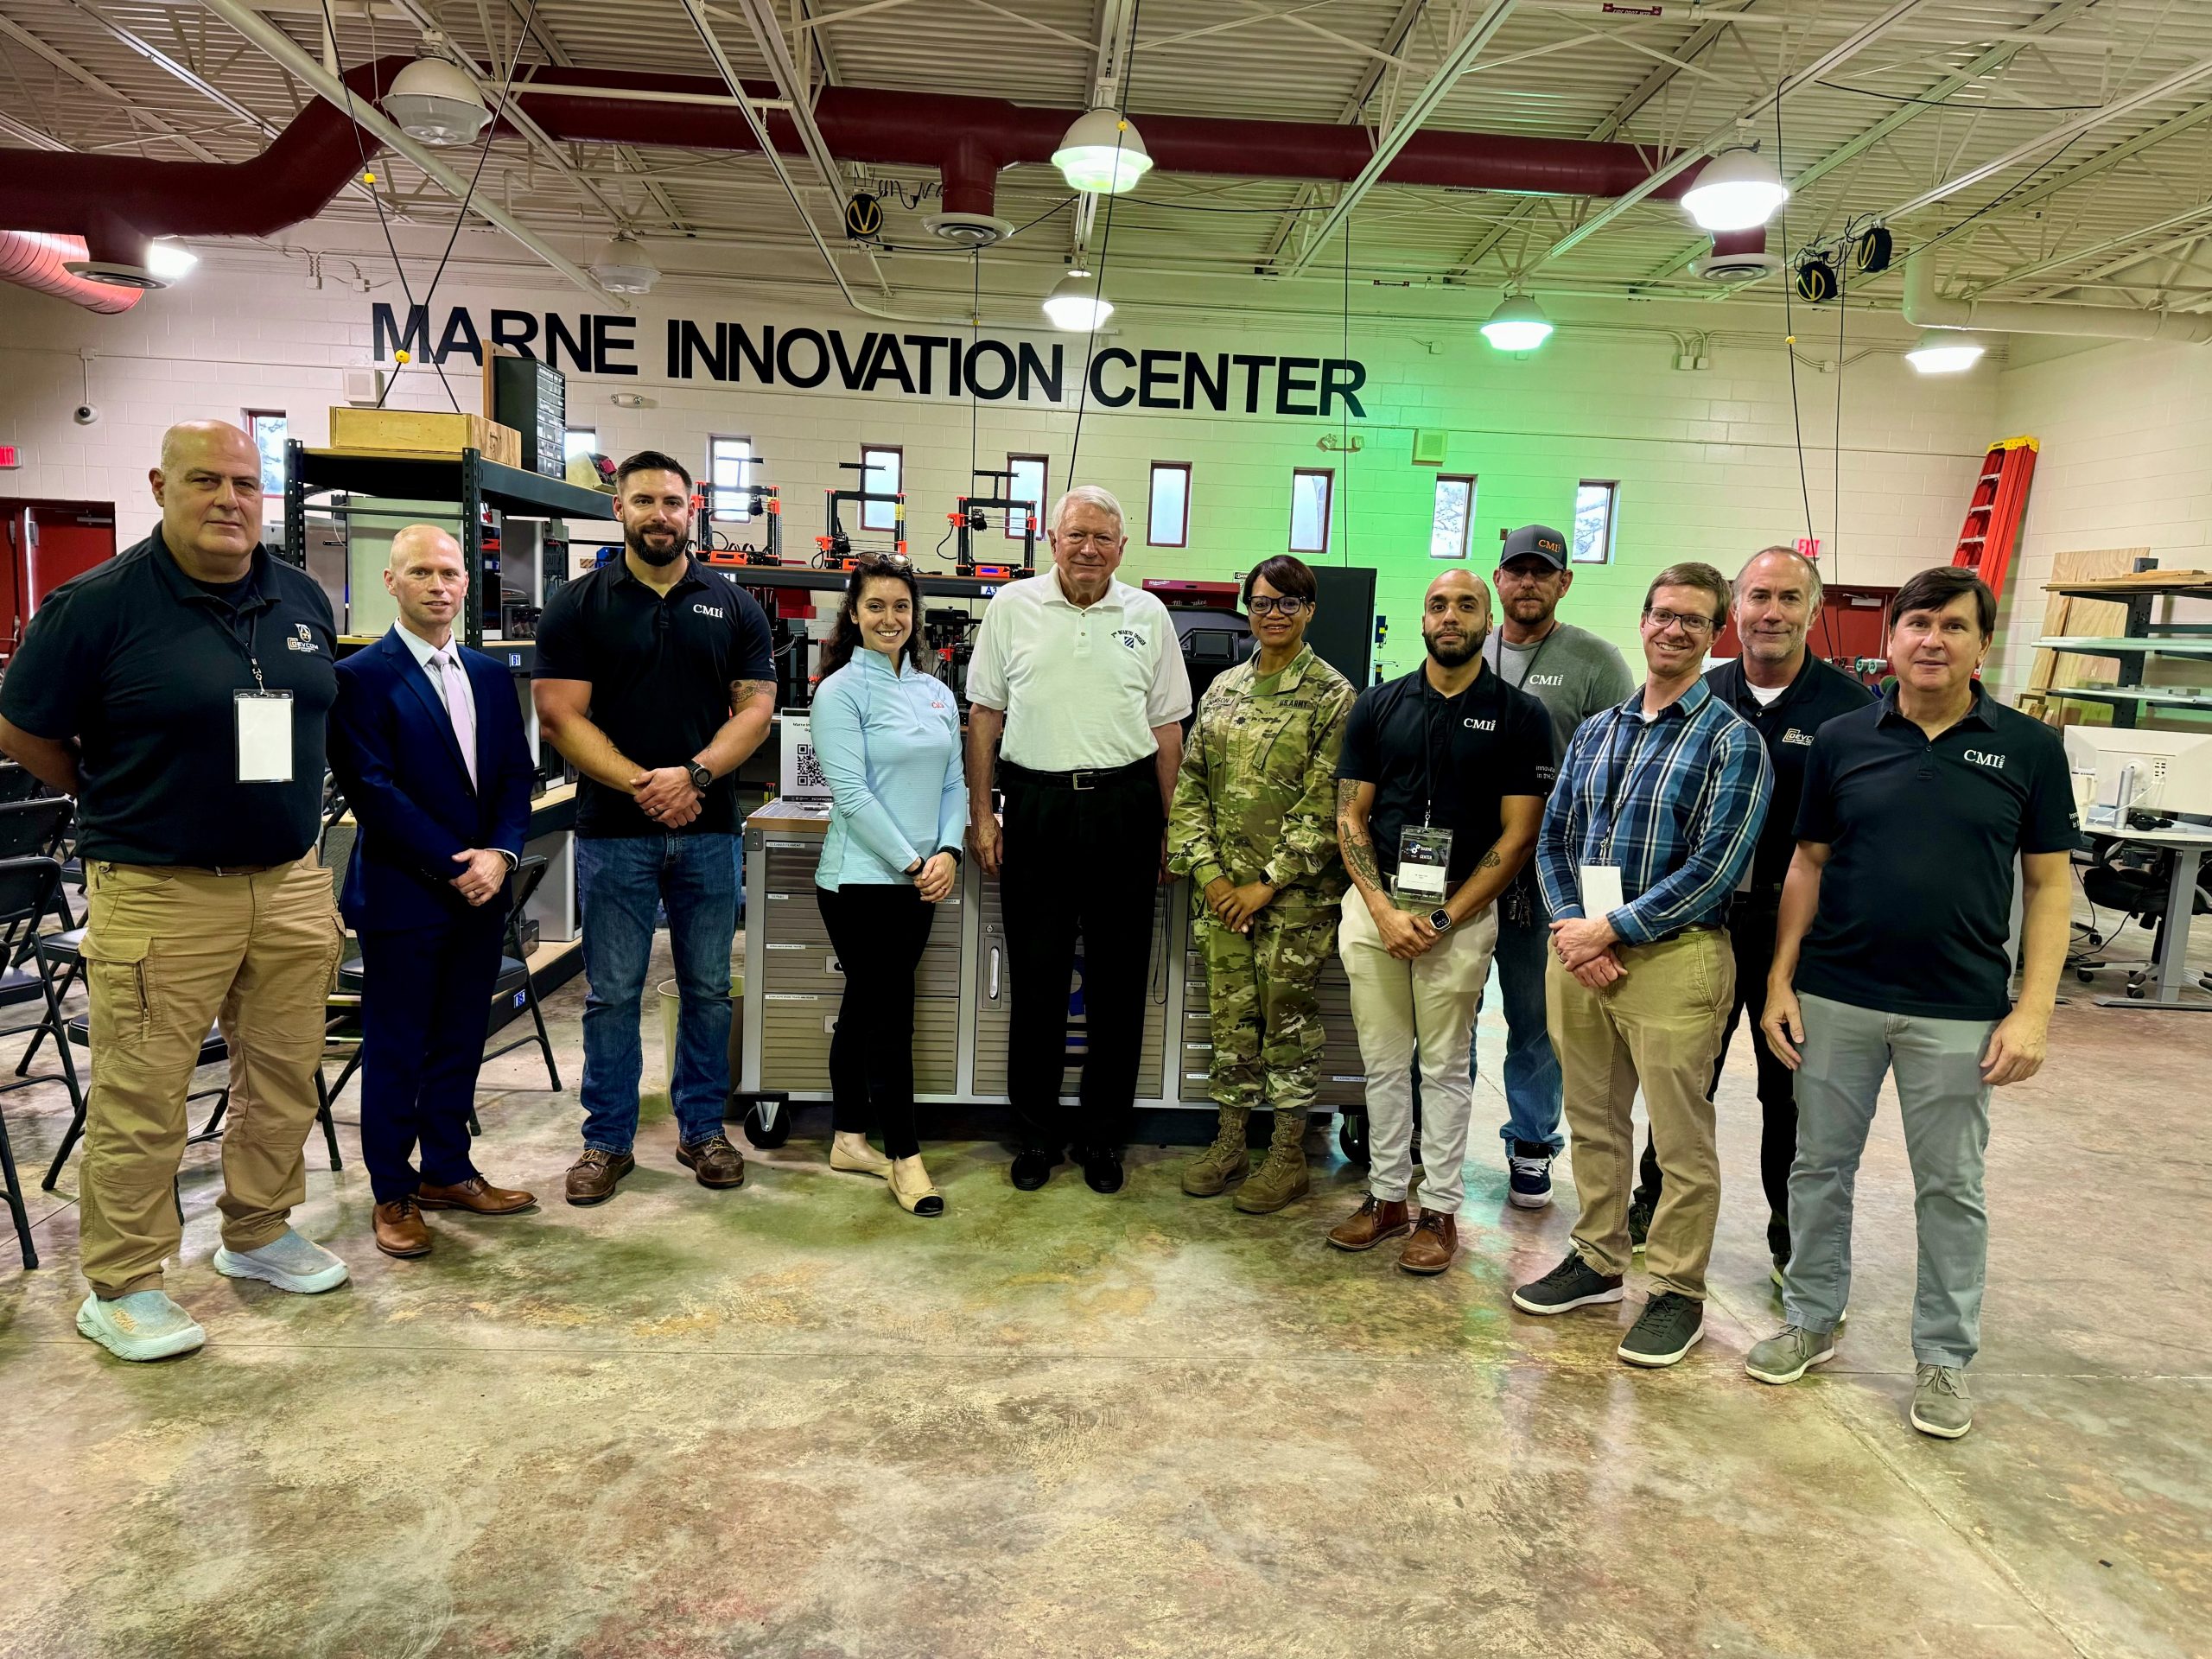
left=0, top=938, right=2212, bottom=1659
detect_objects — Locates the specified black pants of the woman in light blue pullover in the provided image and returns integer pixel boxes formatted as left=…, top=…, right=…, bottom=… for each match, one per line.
left=814, top=882, right=938, bottom=1157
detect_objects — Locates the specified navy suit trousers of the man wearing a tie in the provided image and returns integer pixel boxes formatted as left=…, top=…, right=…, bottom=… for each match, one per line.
left=360, top=902, right=506, bottom=1204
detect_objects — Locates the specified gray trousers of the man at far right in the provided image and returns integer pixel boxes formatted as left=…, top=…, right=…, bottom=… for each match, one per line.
left=1783, top=995, right=1998, bottom=1367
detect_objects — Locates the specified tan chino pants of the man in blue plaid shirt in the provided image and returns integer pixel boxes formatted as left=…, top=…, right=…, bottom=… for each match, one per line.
left=1544, top=927, right=1737, bottom=1300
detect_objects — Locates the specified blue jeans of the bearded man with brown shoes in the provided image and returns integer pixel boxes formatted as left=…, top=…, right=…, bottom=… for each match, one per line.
left=575, top=834, right=736, bottom=1153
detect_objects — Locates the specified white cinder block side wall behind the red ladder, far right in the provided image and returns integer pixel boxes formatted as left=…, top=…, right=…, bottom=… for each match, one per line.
left=1995, top=340, right=2212, bottom=696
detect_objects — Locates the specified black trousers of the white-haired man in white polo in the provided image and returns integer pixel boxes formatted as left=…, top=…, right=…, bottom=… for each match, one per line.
left=998, top=761, right=1166, bottom=1153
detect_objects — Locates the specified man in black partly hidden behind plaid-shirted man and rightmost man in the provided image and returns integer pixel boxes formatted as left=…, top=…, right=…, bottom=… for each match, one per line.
left=1628, top=546, right=1873, bottom=1285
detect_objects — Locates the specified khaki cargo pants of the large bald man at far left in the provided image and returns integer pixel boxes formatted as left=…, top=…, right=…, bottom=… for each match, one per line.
left=79, top=854, right=345, bottom=1299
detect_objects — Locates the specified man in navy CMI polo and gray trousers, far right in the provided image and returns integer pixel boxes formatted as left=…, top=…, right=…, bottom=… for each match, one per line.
left=1745, top=566, right=2079, bottom=1440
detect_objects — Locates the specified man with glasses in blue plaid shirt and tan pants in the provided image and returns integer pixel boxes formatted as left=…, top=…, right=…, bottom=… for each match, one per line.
left=1513, top=564, right=1774, bottom=1365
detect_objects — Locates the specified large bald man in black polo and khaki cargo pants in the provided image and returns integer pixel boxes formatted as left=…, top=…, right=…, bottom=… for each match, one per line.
left=0, top=420, right=345, bottom=1360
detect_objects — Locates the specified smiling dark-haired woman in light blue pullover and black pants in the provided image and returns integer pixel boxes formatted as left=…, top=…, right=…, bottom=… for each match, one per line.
left=814, top=557, right=967, bottom=1214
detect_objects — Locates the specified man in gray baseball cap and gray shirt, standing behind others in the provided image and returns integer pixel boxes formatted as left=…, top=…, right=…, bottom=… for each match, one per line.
left=1469, top=524, right=1637, bottom=1210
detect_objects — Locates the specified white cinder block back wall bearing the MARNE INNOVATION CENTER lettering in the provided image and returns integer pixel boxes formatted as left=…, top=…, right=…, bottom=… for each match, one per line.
left=0, top=261, right=1999, bottom=671
